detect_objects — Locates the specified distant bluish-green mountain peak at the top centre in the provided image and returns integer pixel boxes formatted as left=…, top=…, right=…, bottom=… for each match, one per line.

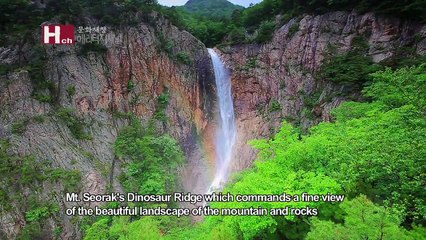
left=183, top=0, right=244, bottom=17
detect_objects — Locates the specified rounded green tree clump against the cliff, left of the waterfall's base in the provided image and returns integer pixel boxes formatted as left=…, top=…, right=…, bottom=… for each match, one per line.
left=114, top=121, right=184, bottom=194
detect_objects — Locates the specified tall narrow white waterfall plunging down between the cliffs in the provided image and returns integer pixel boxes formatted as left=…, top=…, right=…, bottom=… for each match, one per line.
left=207, top=49, right=236, bottom=193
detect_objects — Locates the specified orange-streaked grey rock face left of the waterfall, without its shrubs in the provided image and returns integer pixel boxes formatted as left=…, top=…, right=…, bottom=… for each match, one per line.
left=0, top=14, right=215, bottom=239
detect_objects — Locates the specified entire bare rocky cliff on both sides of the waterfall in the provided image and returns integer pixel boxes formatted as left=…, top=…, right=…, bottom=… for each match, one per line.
left=0, top=8, right=426, bottom=239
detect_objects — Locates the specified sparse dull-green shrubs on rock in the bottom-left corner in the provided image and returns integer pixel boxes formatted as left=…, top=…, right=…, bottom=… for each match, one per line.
left=0, top=140, right=81, bottom=239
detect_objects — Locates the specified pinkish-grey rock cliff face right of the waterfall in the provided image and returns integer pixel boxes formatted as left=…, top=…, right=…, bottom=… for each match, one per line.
left=220, top=12, right=426, bottom=173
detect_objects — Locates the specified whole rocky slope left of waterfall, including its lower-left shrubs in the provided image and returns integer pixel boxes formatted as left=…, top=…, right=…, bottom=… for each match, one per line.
left=0, top=8, right=214, bottom=239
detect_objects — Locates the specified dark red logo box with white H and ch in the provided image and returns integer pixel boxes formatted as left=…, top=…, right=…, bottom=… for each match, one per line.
left=41, top=24, right=75, bottom=45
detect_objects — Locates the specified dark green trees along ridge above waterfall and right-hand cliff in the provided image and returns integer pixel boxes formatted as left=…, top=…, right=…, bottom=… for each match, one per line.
left=170, top=0, right=426, bottom=47
